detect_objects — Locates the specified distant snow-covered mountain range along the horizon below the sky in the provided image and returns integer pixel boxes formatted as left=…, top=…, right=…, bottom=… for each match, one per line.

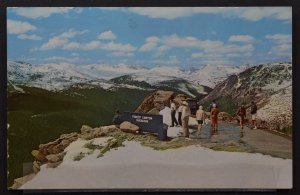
left=8, top=61, right=244, bottom=94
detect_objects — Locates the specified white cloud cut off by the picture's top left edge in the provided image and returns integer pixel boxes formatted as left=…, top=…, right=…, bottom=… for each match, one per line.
left=13, top=7, right=73, bottom=19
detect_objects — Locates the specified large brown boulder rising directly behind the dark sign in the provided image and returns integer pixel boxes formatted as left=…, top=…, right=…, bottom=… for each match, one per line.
left=135, top=90, right=175, bottom=113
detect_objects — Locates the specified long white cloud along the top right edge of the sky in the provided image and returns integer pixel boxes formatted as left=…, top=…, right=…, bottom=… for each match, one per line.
left=101, top=7, right=292, bottom=21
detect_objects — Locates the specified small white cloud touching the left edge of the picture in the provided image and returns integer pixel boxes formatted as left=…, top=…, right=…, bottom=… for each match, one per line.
left=7, top=20, right=37, bottom=34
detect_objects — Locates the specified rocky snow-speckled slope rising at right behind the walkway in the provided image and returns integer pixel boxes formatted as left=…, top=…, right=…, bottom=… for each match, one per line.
left=199, top=62, right=292, bottom=133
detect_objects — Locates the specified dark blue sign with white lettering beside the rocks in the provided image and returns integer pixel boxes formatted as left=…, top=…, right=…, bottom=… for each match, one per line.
left=122, top=112, right=167, bottom=140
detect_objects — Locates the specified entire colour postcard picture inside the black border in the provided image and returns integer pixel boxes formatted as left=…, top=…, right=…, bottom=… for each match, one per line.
left=7, top=7, right=293, bottom=190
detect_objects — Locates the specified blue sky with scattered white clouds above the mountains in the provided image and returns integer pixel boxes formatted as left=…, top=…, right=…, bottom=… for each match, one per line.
left=7, top=7, right=292, bottom=68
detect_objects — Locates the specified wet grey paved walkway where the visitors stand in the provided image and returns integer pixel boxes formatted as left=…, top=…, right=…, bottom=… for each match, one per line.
left=190, top=122, right=293, bottom=159
